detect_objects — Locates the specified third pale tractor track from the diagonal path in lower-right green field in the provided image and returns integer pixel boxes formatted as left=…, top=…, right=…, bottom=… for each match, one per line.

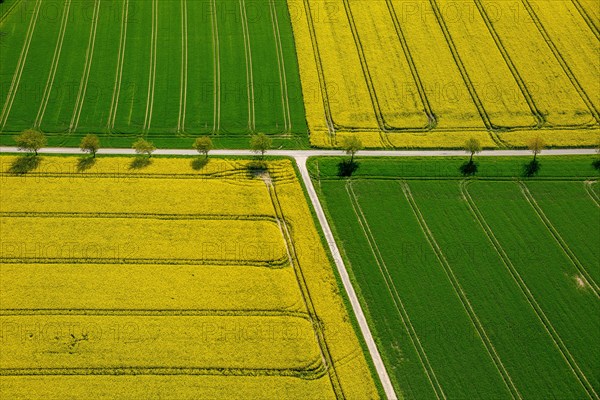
left=459, top=180, right=598, bottom=399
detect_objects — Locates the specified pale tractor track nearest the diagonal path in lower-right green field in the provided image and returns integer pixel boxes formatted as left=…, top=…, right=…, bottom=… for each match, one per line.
left=345, top=181, right=446, bottom=399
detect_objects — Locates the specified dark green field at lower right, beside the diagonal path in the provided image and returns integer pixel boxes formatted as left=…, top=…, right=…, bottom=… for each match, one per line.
left=310, top=157, right=600, bottom=399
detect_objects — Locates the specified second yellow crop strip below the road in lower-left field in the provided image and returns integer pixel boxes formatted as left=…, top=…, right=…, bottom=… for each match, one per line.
left=0, top=214, right=285, bottom=266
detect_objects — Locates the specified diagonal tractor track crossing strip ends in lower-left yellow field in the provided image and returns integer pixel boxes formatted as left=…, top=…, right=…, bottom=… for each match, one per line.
left=264, top=180, right=346, bottom=399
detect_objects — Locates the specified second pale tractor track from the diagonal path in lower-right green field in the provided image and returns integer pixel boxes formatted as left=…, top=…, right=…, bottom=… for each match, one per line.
left=400, top=181, right=523, bottom=399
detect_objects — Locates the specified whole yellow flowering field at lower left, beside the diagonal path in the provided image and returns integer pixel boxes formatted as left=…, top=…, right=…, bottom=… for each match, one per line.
left=0, top=157, right=379, bottom=399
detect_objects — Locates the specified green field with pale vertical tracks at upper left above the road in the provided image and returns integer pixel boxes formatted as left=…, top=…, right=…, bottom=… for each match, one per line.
left=0, top=0, right=308, bottom=147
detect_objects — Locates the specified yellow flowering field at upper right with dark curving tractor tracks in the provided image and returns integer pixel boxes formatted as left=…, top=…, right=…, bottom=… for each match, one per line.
left=288, top=0, right=600, bottom=148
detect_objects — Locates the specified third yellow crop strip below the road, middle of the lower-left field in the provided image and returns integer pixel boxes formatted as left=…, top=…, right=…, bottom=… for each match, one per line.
left=0, top=263, right=302, bottom=312
